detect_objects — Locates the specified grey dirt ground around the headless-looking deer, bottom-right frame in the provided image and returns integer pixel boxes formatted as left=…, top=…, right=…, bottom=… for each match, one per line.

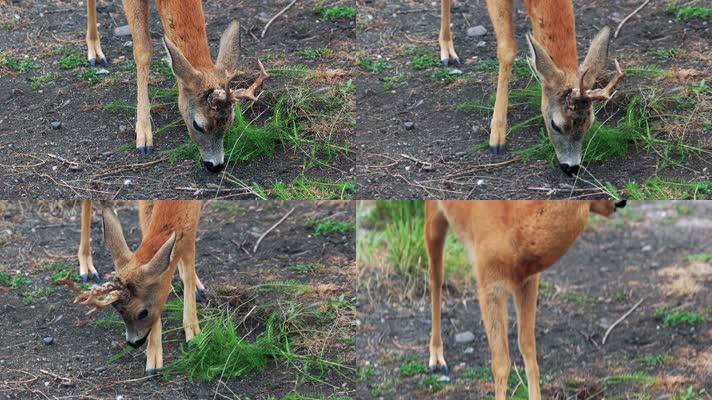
left=357, top=201, right=712, bottom=400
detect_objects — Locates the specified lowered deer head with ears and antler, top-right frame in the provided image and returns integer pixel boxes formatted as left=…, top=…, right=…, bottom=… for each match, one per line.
left=527, top=27, right=624, bottom=175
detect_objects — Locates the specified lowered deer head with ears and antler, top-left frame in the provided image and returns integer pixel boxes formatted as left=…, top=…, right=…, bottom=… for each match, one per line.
left=163, top=21, right=271, bottom=172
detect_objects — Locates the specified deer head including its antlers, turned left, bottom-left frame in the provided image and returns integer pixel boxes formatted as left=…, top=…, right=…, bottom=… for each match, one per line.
left=62, top=208, right=176, bottom=347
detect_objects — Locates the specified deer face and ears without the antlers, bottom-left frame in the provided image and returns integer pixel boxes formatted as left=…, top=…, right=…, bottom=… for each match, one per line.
left=103, top=208, right=176, bottom=347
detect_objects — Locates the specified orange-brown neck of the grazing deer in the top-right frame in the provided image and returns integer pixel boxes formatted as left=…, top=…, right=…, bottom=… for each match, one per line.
left=525, top=0, right=578, bottom=76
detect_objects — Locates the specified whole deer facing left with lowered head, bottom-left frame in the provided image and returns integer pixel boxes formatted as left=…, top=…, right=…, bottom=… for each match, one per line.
left=60, top=200, right=205, bottom=377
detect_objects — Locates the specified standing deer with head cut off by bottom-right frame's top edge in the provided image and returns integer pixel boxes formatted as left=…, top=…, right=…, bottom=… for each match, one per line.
left=424, top=200, right=626, bottom=400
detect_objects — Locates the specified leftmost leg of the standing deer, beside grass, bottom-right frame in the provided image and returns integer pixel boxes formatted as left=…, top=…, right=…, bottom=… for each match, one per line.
left=425, top=202, right=448, bottom=373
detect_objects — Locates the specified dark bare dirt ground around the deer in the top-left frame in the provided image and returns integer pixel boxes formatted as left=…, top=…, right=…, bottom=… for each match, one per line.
left=0, top=0, right=355, bottom=199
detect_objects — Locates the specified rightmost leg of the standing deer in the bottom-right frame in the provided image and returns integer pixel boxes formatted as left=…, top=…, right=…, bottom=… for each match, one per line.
left=514, top=274, right=541, bottom=400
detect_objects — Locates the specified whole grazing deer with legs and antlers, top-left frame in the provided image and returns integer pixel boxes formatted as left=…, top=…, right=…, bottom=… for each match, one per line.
left=86, top=0, right=272, bottom=173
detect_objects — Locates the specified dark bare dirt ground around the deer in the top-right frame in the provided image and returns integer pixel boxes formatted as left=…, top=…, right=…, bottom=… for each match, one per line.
left=355, top=0, right=712, bottom=199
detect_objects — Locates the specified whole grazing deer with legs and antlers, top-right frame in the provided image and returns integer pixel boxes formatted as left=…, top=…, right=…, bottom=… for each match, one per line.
left=439, top=0, right=625, bottom=176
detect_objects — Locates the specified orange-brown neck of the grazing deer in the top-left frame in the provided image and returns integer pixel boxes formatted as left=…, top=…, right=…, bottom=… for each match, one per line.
left=156, top=0, right=213, bottom=72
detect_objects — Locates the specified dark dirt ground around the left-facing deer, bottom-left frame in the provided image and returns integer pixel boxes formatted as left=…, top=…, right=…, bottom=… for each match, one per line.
left=0, top=201, right=356, bottom=399
